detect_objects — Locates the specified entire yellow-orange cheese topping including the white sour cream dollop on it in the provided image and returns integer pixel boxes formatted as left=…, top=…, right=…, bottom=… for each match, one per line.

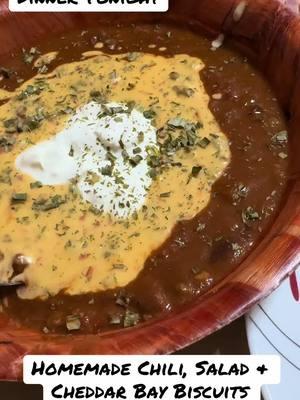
left=0, top=51, right=231, bottom=299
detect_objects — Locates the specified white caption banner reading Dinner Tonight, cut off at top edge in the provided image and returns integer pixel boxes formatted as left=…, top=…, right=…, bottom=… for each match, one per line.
left=9, top=0, right=169, bottom=12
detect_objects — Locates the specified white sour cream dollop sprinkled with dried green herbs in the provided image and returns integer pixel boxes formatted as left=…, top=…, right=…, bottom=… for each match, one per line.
left=16, top=102, right=157, bottom=218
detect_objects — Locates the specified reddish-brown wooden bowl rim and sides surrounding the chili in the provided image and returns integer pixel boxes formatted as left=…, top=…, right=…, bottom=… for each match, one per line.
left=0, top=0, right=300, bottom=380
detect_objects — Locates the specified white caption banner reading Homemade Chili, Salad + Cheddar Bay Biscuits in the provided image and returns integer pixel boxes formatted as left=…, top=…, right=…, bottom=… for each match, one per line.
left=23, top=355, right=280, bottom=400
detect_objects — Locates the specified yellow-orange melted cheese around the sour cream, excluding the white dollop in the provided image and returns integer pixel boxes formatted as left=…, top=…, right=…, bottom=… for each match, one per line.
left=0, top=52, right=230, bottom=298
